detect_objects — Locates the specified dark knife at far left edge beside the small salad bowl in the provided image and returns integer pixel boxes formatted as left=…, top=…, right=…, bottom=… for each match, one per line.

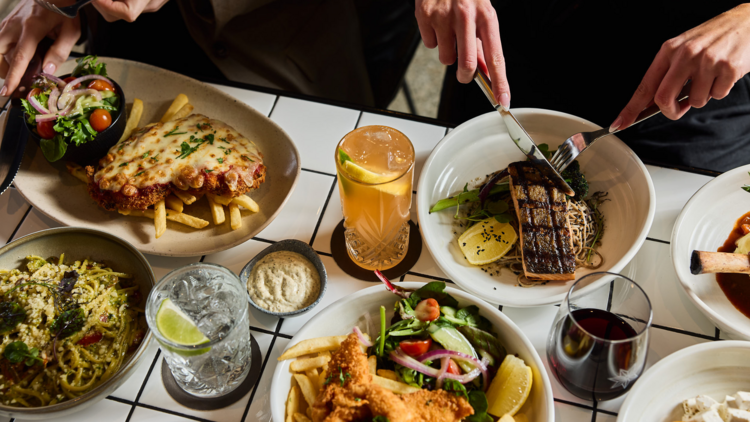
left=0, top=39, right=52, bottom=194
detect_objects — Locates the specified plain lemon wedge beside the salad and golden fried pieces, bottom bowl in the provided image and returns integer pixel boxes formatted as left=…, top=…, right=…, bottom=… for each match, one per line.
left=487, top=355, right=532, bottom=416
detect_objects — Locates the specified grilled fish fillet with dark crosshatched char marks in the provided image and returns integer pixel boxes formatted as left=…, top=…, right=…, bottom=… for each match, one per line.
left=508, top=161, right=576, bottom=280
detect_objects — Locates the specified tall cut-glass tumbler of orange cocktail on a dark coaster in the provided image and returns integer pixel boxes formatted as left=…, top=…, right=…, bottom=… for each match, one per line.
left=336, top=126, right=414, bottom=270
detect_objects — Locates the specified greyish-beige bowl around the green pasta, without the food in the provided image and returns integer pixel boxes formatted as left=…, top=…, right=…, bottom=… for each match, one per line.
left=0, top=227, right=156, bottom=420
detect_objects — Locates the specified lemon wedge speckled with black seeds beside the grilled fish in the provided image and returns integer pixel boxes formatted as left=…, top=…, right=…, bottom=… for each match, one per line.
left=458, top=218, right=518, bottom=265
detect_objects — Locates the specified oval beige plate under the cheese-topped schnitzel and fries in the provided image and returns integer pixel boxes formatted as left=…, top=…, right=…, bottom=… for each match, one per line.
left=14, top=57, right=301, bottom=256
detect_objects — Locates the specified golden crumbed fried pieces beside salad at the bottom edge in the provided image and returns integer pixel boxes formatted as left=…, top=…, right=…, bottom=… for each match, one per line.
left=311, top=334, right=474, bottom=422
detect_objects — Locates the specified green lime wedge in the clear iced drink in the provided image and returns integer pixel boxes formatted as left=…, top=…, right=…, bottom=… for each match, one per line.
left=156, top=298, right=211, bottom=356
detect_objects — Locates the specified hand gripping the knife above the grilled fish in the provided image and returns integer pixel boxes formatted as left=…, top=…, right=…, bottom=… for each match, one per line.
left=416, top=0, right=510, bottom=108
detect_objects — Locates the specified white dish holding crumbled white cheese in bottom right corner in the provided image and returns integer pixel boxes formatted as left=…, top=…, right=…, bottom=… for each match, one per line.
left=617, top=341, right=750, bottom=422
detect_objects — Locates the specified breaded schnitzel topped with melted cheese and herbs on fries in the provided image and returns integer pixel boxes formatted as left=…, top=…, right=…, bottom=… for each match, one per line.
left=86, top=114, right=266, bottom=211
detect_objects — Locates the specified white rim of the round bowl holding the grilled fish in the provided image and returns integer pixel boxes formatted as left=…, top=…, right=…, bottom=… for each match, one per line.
left=417, top=108, right=656, bottom=307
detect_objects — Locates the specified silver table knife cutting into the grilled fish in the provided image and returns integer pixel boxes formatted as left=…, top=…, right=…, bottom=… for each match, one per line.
left=474, top=69, right=575, bottom=196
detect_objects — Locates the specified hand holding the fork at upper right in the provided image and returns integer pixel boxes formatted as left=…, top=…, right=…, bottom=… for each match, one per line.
left=609, top=4, right=750, bottom=132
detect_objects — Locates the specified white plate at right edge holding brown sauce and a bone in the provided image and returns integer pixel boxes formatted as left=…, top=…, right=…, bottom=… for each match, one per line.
left=670, top=165, right=750, bottom=339
